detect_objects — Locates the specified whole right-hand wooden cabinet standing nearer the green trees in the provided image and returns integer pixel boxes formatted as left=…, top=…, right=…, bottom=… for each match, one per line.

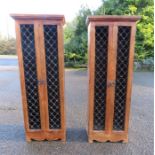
left=87, top=16, right=140, bottom=142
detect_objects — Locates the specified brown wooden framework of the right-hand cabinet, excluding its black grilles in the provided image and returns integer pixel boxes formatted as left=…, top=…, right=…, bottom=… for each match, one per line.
left=87, top=16, right=140, bottom=143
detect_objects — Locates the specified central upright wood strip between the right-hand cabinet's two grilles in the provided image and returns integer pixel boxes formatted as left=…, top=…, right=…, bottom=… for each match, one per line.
left=105, top=24, right=117, bottom=134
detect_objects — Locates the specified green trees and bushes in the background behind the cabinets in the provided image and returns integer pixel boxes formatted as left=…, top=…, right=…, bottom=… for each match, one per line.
left=0, top=0, right=154, bottom=67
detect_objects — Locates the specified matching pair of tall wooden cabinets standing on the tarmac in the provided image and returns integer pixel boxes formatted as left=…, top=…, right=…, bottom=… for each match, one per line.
left=11, top=14, right=139, bottom=142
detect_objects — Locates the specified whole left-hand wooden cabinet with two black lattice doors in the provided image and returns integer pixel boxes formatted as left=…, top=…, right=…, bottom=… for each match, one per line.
left=11, top=14, right=66, bottom=141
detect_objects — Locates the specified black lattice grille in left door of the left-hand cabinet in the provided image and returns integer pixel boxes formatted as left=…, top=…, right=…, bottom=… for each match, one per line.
left=20, top=24, right=41, bottom=129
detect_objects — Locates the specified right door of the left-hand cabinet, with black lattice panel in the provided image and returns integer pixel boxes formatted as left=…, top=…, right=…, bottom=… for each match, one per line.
left=42, top=21, right=64, bottom=130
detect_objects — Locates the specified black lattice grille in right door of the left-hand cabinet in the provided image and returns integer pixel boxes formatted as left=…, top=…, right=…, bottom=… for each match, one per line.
left=44, top=25, right=61, bottom=129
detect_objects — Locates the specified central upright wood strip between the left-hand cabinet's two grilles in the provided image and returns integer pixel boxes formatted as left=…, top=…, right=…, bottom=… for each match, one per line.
left=35, top=20, right=49, bottom=132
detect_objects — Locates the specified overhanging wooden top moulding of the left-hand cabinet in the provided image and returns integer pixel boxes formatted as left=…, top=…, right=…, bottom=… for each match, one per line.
left=10, top=14, right=65, bottom=24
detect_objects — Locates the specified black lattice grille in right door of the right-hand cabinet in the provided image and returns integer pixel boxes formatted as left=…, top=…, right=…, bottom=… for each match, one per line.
left=113, top=26, right=131, bottom=130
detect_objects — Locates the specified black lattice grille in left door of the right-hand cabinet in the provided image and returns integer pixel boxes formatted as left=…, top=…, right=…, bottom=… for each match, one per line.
left=94, top=26, right=108, bottom=130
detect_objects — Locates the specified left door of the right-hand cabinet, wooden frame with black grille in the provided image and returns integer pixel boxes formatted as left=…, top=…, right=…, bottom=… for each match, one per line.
left=89, top=23, right=115, bottom=132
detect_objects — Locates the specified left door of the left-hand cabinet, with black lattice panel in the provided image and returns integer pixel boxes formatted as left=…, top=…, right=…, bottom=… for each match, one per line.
left=17, top=22, right=41, bottom=130
